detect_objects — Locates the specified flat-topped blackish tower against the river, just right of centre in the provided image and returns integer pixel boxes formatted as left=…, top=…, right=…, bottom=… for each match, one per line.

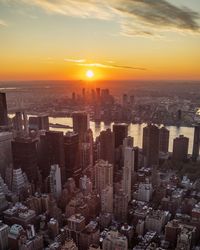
left=113, top=123, right=128, bottom=148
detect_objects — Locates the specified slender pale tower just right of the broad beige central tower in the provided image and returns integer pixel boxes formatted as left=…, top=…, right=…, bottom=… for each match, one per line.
left=122, top=147, right=134, bottom=201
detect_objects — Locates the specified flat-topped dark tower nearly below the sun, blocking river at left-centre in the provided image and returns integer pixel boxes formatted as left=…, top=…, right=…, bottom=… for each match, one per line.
left=72, top=111, right=89, bottom=141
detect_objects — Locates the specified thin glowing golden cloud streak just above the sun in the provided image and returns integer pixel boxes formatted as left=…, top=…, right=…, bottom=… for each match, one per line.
left=64, top=60, right=146, bottom=70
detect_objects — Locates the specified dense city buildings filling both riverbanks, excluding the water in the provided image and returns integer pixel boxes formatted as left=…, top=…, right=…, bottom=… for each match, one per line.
left=0, top=88, right=200, bottom=250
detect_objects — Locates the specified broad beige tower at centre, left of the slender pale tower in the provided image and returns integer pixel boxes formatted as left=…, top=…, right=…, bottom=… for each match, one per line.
left=94, top=160, right=113, bottom=194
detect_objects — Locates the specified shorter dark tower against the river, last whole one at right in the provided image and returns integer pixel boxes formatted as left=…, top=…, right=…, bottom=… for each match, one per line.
left=172, top=135, right=189, bottom=161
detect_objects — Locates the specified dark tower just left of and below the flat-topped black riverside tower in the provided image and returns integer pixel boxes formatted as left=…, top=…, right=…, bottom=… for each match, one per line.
left=99, top=129, right=115, bottom=164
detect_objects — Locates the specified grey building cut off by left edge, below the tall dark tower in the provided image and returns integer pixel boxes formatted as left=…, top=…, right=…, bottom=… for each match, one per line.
left=0, top=132, right=13, bottom=178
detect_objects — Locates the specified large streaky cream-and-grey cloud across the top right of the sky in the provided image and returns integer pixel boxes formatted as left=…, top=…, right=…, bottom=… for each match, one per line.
left=8, top=0, right=200, bottom=36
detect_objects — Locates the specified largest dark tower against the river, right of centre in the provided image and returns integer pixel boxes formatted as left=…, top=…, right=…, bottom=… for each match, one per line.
left=142, top=124, right=159, bottom=166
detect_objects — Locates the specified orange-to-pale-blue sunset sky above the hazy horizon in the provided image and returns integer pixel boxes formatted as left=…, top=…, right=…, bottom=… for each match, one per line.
left=0, top=0, right=200, bottom=80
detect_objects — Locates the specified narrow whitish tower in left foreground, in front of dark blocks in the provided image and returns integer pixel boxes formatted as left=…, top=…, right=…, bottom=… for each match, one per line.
left=49, top=164, right=62, bottom=199
